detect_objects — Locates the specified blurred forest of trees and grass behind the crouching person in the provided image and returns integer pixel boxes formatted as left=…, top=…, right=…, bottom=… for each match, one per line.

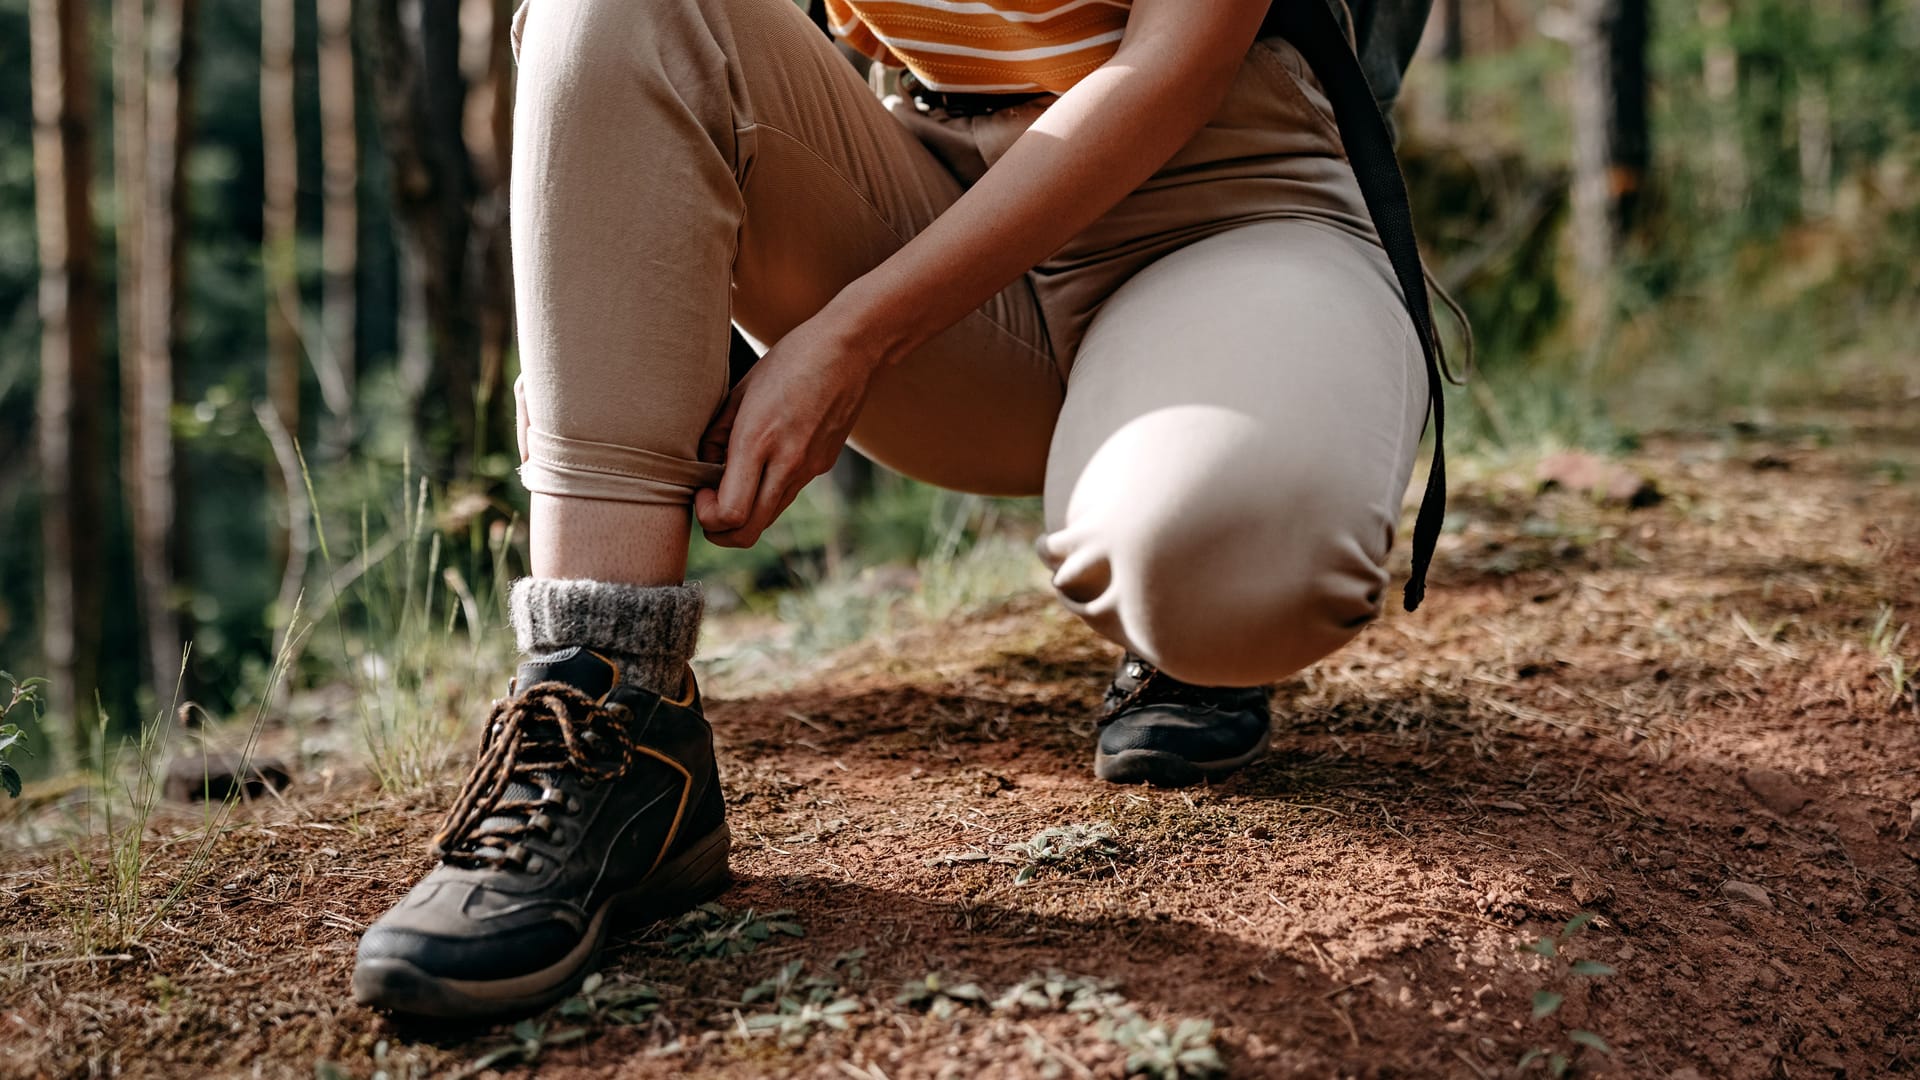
left=0, top=0, right=1920, bottom=769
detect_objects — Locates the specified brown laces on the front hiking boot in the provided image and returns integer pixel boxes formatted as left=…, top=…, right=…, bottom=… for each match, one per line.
left=432, top=682, right=637, bottom=869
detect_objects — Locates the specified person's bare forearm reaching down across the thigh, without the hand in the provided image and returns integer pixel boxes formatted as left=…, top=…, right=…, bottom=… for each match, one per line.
left=831, top=0, right=1265, bottom=363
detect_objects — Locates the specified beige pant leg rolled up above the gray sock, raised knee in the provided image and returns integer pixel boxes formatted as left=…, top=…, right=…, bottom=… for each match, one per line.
left=511, top=0, right=1062, bottom=503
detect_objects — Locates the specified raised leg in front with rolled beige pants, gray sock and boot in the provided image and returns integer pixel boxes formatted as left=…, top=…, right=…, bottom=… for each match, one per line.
left=353, top=0, right=975, bottom=1017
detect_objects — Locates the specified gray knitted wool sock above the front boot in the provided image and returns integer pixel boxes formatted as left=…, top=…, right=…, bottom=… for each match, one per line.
left=509, top=578, right=707, bottom=696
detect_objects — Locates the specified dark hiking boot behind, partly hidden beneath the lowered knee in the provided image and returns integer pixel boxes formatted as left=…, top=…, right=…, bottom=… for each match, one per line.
left=1092, top=653, right=1273, bottom=788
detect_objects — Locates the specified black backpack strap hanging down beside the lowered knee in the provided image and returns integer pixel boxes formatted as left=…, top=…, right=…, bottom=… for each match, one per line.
left=1260, top=0, right=1446, bottom=611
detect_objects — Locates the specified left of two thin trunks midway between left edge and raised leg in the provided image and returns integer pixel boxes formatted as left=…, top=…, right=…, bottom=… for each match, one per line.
left=259, top=0, right=303, bottom=607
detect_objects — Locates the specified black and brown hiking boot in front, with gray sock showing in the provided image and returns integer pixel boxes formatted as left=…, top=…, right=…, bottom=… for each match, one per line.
left=353, top=648, right=730, bottom=1017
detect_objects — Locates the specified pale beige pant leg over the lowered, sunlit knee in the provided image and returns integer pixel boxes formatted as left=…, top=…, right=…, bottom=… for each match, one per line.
left=1041, top=221, right=1427, bottom=686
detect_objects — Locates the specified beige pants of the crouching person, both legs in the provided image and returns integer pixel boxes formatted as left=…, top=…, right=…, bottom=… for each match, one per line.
left=511, top=0, right=1427, bottom=684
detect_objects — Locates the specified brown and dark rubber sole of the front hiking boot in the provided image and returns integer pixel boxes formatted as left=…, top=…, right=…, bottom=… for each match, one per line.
left=353, top=822, right=733, bottom=1020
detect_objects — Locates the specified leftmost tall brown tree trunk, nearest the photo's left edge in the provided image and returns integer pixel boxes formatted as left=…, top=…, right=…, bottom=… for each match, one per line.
left=29, top=0, right=104, bottom=765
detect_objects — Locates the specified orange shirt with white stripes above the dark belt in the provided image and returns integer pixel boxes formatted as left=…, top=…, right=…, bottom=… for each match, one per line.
left=826, top=0, right=1131, bottom=94
